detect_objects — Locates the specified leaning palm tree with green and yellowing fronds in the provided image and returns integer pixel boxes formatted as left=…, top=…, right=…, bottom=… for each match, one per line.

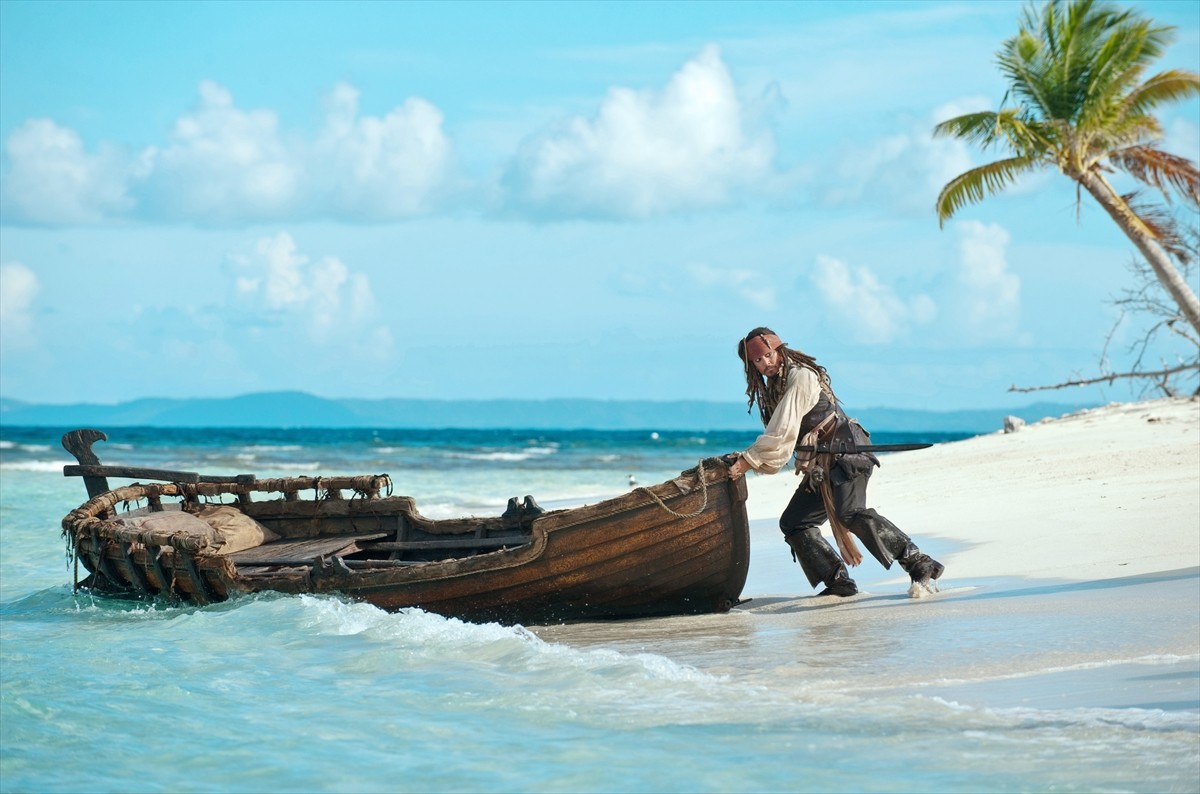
left=934, top=0, right=1200, bottom=332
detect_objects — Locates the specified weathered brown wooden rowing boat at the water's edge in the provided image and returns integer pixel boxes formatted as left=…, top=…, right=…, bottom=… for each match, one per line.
left=62, top=429, right=750, bottom=624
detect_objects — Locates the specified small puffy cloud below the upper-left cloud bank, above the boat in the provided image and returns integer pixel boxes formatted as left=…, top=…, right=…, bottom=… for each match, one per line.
left=233, top=231, right=391, bottom=356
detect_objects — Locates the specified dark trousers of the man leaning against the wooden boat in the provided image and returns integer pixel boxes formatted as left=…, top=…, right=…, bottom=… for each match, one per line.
left=779, top=461, right=919, bottom=587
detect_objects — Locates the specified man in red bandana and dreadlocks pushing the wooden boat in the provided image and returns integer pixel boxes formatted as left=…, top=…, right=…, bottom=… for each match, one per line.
left=730, top=327, right=944, bottom=597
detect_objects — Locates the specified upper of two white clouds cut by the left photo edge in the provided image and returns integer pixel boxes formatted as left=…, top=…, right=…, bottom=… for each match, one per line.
left=0, top=119, right=133, bottom=225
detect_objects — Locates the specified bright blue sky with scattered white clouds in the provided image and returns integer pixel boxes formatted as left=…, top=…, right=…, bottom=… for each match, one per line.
left=0, top=0, right=1200, bottom=410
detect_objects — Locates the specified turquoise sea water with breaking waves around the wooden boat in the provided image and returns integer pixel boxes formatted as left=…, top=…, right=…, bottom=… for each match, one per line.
left=0, top=427, right=1200, bottom=792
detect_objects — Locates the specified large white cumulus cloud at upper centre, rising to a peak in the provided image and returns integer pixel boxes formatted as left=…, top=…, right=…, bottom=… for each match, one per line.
left=504, top=46, right=774, bottom=218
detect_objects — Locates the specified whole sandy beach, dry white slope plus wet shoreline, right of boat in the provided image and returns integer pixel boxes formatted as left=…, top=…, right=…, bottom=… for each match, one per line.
left=720, top=399, right=1200, bottom=730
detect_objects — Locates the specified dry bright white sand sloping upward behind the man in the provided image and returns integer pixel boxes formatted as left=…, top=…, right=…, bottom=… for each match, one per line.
left=748, top=398, right=1200, bottom=595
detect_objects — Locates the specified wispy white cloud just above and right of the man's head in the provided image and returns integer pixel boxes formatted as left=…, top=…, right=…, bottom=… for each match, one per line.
left=811, top=254, right=937, bottom=344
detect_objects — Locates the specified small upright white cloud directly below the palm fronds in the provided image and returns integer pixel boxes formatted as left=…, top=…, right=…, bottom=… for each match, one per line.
left=953, top=221, right=1021, bottom=342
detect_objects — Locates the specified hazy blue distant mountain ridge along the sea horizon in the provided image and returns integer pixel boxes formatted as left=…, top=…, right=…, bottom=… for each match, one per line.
left=0, top=391, right=1090, bottom=433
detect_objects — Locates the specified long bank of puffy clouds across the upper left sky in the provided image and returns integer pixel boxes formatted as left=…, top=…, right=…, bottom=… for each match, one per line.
left=0, top=80, right=452, bottom=225
